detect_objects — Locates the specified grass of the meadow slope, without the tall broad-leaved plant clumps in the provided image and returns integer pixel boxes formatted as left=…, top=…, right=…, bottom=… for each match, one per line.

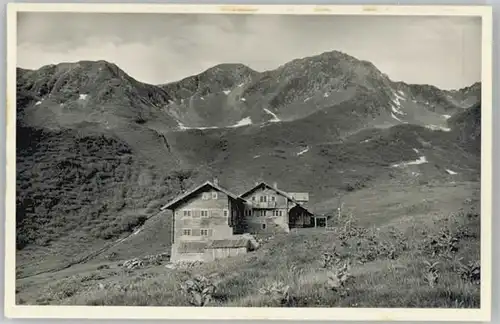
left=17, top=182, right=479, bottom=307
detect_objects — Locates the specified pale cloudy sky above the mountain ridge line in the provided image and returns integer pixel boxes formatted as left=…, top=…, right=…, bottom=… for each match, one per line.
left=17, top=13, right=481, bottom=89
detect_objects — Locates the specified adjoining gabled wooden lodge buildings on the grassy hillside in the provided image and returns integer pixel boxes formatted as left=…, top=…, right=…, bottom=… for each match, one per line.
left=161, top=180, right=314, bottom=262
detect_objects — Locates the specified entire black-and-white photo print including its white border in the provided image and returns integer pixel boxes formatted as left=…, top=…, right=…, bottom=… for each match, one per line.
left=6, top=5, right=491, bottom=320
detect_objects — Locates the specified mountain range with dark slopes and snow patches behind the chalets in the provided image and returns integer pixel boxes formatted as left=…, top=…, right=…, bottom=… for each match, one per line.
left=13, top=52, right=480, bottom=275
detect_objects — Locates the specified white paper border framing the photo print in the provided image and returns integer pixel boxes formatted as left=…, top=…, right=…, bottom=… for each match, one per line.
left=4, top=3, right=493, bottom=322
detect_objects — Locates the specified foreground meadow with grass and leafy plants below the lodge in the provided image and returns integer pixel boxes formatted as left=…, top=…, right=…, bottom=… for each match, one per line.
left=18, top=194, right=480, bottom=308
